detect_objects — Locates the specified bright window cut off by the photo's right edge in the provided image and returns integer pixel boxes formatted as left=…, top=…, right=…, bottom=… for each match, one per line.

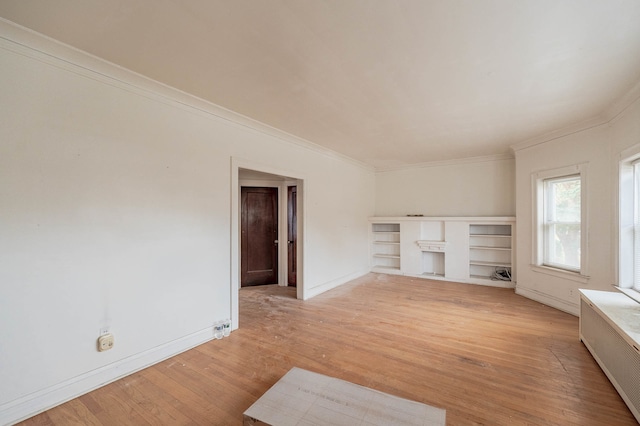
left=618, top=147, right=640, bottom=291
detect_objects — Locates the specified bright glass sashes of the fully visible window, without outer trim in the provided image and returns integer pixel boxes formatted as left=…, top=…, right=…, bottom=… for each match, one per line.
left=542, top=175, right=581, bottom=271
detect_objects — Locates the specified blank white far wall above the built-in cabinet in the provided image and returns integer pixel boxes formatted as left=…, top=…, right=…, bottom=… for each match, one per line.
left=376, top=158, right=515, bottom=216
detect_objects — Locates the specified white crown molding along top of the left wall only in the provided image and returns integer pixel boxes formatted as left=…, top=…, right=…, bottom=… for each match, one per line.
left=0, top=17, right=374, bottom=172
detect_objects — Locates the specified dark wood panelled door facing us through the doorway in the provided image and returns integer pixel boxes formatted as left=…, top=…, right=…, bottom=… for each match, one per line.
left=240, top=187, right=278, bottom=287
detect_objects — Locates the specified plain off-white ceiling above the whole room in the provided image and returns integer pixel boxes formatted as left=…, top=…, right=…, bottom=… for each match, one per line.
left=0, top=0, right=640, bottom=167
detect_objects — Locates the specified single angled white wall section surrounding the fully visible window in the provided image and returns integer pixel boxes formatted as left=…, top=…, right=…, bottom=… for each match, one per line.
left=516, top=125, right=613, bottom=314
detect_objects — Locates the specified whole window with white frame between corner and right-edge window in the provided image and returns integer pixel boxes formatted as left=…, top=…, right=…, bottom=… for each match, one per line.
left=532, top=164, right=588, bottom=276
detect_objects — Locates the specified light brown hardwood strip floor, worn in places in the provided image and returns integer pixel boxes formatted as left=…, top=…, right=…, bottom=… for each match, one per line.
left=18, top=274, right=636, bottom=426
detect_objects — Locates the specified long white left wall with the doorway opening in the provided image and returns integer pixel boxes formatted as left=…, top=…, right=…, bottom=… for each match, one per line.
left=0, top=22, right=374, bottom=424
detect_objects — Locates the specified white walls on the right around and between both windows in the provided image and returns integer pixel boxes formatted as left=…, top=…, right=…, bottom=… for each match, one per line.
left=515, top=86, right=640, bottom=315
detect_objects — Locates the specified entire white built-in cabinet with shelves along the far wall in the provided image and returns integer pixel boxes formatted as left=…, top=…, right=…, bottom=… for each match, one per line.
left=369, top=217, right=516, bottom=287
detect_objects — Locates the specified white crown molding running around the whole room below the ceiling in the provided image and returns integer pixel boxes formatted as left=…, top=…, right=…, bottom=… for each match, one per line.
left=0, top=17, right=640, bottom=173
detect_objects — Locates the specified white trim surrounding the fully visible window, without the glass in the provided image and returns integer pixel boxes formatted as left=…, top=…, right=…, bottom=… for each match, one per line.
left=531, top=163, right=589, bottom=283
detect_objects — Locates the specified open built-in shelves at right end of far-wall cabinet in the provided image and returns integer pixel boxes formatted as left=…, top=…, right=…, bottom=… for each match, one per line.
left=469, top=224, right=512, bottom=281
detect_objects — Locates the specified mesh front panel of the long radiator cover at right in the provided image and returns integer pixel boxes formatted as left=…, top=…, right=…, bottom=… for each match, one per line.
left=580, top=294, right=640, bottom=422
